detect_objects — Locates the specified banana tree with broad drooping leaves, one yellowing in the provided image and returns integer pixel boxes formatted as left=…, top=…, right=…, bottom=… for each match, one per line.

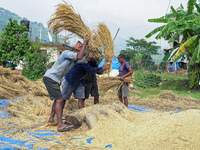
left=146, top=0, right=200, bottom=88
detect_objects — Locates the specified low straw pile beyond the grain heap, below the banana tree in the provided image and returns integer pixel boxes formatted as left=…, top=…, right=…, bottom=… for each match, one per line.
left=129, top=91, right=200, bottom=110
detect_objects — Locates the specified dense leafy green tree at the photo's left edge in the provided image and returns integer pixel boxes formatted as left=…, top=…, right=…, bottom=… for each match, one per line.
left=0, top=18, right=31, bottom=65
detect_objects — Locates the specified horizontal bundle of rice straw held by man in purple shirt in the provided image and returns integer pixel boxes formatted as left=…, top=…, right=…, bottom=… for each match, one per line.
left=98, top=76, right=134, bottom=93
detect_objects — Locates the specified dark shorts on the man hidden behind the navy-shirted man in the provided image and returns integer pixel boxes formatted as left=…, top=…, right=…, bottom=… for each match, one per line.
left=85, top=81, right=99, bottom=99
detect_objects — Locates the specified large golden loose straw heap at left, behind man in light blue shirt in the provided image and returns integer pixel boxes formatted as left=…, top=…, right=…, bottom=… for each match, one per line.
left=0, top=66, right=88, bottom=120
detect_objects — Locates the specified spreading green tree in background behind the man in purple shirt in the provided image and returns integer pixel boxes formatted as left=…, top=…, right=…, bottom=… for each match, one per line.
left=120, top=37, right=159, bottom=69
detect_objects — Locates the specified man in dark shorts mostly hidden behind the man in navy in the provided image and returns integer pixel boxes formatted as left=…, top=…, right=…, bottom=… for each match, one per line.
left=84, top=57, right=102, bottom=104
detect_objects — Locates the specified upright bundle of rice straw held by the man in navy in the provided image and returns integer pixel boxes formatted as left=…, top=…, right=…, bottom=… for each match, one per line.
left=95, top=23, right=114, bottom=73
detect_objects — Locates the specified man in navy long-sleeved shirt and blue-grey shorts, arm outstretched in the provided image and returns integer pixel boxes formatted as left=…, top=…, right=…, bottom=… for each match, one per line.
left=62, top=55, right=110, bottom=109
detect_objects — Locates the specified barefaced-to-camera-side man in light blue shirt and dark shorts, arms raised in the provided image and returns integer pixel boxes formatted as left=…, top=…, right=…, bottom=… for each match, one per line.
left=43, top=36, right=90, bottom=132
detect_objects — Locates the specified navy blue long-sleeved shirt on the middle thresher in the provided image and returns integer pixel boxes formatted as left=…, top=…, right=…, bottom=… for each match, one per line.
left=65, top=61, right=102, bottom=86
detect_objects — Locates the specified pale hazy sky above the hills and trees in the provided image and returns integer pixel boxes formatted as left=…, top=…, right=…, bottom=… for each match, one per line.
left=0, top=0, right=188, bottom=47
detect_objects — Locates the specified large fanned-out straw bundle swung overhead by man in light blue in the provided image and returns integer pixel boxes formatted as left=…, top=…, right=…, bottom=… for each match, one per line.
left=48, top=1, right=100, bottom=58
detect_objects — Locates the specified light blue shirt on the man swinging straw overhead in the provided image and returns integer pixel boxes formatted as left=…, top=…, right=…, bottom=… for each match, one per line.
left=44, top=50, right=87, bottom=84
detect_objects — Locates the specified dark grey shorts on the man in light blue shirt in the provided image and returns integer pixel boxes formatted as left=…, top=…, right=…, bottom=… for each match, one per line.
left=43, top=77, right=63, bottom=100
